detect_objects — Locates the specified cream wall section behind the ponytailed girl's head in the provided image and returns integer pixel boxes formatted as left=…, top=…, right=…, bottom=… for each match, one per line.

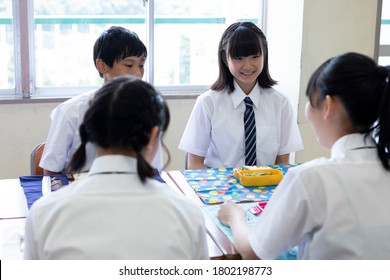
left=296, top=0, right=378, bottom=162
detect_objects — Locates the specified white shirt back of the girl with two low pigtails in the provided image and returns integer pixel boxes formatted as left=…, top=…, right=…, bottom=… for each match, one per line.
left=24, top=155, right=209, bottom=260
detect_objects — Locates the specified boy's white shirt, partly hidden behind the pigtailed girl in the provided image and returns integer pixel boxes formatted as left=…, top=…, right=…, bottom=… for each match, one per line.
left=39, top=90, right=164, bottom=172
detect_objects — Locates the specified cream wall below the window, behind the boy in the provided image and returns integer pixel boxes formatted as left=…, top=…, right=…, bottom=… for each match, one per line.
left=0, top=99, right=195, bottom=179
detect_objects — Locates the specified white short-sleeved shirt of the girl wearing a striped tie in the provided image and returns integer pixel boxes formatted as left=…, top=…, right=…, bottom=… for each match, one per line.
left=179, top=82, right=303, bottom=167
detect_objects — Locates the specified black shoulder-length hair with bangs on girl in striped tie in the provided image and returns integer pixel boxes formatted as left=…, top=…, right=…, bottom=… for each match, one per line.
left=210, top=21, right=277, bottom=93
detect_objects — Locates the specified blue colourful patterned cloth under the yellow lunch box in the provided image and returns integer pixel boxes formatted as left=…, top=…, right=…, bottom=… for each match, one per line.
left=181, top=164, right=297, bottom=204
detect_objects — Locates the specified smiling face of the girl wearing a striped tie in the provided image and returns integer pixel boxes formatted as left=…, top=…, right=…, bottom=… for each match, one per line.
left=227, top=54, right=264, bottom=94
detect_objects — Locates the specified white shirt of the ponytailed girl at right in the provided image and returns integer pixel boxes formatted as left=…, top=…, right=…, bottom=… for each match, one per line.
left=249, top=134, right=390, bottom=260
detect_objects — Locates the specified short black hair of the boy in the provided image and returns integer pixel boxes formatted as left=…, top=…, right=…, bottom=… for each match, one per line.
left=93, top=26, right=148, bottom=78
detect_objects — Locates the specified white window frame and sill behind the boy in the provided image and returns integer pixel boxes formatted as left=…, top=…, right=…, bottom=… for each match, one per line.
left=0, top=0, right=267, bottom=100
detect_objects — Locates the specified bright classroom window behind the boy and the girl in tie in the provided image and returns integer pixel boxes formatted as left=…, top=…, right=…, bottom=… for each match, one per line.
left=0, top=0, right=263, bottom=98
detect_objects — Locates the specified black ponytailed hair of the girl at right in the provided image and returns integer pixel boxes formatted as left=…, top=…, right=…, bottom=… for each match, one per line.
left=306, top=52, right=390, bottom=170
